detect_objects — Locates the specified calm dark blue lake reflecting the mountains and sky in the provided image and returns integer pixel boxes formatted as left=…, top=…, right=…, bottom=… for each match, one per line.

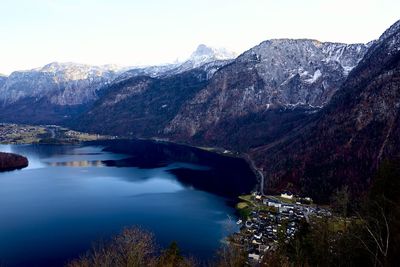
left=0, top=141, right=255, bottom=267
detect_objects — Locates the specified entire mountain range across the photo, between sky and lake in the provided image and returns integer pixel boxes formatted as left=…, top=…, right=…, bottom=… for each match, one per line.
left=0, top=21, right=400, bottom=201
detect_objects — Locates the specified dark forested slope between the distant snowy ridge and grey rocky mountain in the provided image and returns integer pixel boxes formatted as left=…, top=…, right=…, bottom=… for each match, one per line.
left=71, top=68, right=208, bottom=137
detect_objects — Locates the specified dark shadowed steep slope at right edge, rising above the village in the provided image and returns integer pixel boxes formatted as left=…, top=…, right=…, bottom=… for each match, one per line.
left=251, top=21, right=400, bottom=201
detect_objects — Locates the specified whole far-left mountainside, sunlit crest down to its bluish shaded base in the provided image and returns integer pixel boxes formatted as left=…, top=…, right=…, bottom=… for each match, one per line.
left=0, top=63, right=117, bottom=123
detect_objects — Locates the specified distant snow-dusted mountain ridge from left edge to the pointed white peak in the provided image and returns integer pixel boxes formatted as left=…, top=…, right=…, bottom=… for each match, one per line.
left=0, top=45, right=234, bottom=124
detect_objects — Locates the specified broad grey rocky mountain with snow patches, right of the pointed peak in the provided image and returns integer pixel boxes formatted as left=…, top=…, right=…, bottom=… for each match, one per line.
left=164, top=39, right=368, bottom=149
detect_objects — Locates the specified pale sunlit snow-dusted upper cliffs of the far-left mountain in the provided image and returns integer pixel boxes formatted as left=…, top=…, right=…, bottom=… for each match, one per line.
left=0, top=63, right=117, bottom=106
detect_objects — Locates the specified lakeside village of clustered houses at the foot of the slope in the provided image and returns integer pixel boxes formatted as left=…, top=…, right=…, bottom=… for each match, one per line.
left=232, top=192, right=332, bottom=265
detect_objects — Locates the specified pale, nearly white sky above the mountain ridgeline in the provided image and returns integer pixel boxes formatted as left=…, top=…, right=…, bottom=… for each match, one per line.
left=0, top=0, right=400, bottom=74
